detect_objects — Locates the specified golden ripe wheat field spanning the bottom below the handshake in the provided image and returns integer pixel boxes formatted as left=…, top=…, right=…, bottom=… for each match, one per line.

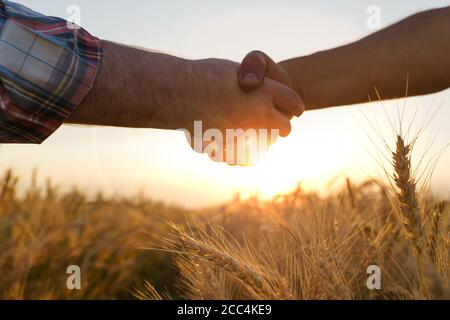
left=0, top=131, right=450, bottom=299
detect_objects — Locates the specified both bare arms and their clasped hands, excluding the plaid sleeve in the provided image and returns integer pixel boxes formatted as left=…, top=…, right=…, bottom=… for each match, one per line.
left=67, top=7, right=450, bottom=165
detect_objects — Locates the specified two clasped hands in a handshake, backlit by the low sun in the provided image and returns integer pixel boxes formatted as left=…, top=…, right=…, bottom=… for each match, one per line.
left=184, top=51, right=305, bottom=165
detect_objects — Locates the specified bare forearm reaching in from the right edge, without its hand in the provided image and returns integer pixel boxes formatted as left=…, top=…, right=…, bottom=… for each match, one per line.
left=280, top=7, right=450, bottom=109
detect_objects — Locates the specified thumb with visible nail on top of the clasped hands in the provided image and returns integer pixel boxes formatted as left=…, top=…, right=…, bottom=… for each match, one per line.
left=238, top=51, right=292, bottom=92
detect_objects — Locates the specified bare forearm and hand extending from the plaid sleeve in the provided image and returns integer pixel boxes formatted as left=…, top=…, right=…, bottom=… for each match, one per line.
left=68, top=41, right=301, bottom=135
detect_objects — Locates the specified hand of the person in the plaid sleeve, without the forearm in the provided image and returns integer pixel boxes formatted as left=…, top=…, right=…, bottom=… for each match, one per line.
left=188, top=59, right=303, bottom=137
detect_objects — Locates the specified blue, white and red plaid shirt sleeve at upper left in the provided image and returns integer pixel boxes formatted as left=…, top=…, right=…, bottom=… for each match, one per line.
left=0, top=1, right=101, bottom=143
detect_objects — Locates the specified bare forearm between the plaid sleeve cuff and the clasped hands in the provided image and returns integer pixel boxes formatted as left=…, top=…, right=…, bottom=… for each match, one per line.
left=67, top=41, right=198, bottom=129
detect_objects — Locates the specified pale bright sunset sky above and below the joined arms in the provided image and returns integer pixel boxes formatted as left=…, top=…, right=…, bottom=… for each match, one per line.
left=0, top=0, right=450, bottom=207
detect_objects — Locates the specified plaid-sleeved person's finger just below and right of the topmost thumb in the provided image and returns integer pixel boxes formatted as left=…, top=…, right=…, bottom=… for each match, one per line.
left=266, top=79, right=305, bottom=119
